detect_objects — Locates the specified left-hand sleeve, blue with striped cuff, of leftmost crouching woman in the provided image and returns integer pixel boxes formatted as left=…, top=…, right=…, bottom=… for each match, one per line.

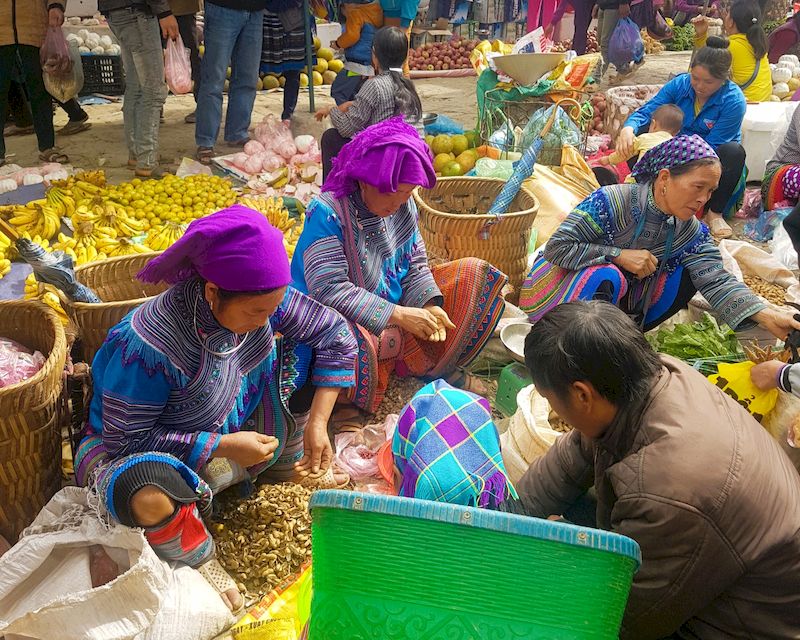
left=94, top=350, right=221, bottom=471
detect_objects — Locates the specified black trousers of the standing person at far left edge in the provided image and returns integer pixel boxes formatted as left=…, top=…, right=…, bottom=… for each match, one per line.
left=0, top=44, right=56, bottom=158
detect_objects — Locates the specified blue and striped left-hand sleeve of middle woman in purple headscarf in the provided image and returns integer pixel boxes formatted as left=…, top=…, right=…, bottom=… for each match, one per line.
left=292, top=201, right=395, bottom=335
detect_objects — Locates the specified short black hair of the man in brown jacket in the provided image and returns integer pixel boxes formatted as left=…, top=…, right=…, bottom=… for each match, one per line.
left=525, top=300, right=662, bottom=407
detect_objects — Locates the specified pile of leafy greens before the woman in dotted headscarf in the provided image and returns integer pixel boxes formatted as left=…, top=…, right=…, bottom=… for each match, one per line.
left=648, top=313, right=740, bottom=360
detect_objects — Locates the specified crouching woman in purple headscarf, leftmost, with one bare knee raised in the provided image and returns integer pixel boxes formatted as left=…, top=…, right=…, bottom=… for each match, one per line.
left=75, top=205, right=356, bottom=610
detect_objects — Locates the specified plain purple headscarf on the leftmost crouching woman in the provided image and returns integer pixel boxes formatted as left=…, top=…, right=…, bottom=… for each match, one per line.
left=137, top=204, right=292, bottom=292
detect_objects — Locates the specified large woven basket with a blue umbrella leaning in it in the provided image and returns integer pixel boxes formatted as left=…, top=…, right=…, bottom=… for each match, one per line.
left=414, top=178, right=539, bottom=292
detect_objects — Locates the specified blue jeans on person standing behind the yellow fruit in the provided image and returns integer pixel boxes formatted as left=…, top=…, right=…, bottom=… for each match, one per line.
left=194, top=2, right=264, bottom=147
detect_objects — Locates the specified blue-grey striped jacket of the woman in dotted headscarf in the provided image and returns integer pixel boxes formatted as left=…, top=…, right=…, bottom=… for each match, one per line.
left=520, top=183, right=764, bottom=328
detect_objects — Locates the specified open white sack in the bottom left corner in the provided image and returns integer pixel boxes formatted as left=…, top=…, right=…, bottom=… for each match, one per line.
left=0, top=487, right=232, bottom=640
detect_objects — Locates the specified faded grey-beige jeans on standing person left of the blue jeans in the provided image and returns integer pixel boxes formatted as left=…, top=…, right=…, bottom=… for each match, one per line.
left=108, top=8, right=167, bottom=170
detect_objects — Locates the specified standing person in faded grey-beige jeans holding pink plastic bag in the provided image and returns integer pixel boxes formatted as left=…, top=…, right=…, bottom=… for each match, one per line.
left=98, top=0, right=178, bottom=178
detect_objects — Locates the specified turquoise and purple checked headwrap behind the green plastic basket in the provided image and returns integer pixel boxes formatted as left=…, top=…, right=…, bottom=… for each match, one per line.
left=392, top=380, right=517, bottom=508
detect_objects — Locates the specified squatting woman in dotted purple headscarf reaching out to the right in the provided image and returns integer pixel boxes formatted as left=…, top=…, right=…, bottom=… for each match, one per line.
left=520, top=136, right=800, bottom=339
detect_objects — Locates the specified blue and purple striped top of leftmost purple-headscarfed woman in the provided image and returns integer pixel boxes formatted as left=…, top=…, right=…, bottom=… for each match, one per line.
left=76, top=280, right=357, bottom=482
